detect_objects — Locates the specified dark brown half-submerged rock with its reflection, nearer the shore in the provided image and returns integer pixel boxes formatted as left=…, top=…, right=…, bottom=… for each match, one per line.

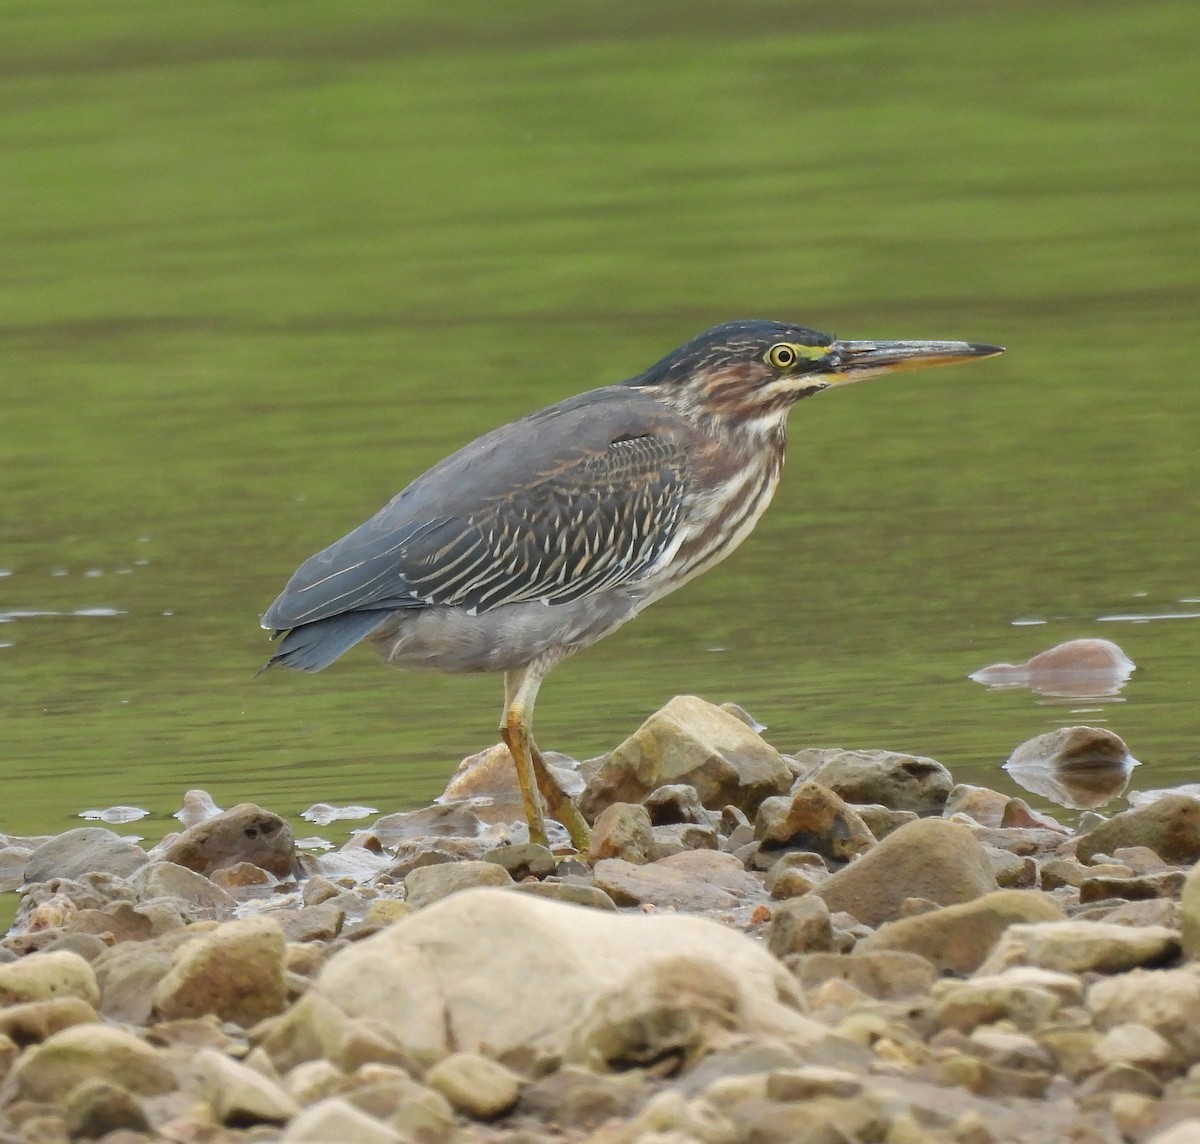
left=1004, top=726, right=1138, bottom=810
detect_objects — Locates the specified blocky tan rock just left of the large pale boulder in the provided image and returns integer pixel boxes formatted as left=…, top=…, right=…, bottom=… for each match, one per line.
left=154, top=917, right=287, bottom=1026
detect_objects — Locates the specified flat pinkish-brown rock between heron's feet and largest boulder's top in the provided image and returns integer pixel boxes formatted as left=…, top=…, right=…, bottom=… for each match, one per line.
left=594, top=850, right=763, bottom=912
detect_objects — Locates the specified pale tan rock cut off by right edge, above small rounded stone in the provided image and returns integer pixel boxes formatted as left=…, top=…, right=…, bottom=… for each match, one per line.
left=1086, top=969, right=1200, bottom=1068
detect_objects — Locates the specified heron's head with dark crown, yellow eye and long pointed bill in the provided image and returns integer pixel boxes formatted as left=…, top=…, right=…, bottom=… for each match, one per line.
left=626, top=319, right=1003, bottom=431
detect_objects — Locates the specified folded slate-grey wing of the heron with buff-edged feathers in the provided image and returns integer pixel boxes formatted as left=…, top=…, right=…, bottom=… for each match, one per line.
left=263, top=387, right=688, bottom=630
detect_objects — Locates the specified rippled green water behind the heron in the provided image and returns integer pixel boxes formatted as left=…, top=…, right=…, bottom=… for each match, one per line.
left=0, top=0, right=1200, bottom=837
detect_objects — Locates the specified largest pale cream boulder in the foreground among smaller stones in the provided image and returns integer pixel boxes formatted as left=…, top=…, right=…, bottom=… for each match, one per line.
left=262, top=888, right=827, bottom=1068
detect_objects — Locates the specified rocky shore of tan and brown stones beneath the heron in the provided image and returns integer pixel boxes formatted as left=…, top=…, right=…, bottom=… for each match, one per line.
left=0, top=696, right=1200, bottom=1144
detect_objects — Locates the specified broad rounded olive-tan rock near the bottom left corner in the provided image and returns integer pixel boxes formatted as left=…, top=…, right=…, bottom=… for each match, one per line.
left=11, top=1025, right=175, bottom=1101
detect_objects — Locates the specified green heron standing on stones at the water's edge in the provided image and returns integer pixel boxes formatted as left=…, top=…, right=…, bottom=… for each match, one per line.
left=262, top=321, right=1002, bottom=850
